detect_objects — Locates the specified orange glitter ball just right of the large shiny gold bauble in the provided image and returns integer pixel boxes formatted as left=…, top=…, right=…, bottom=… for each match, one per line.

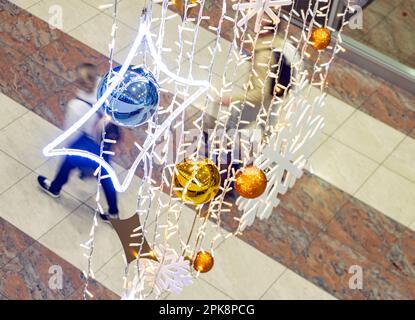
left=235, top=166, right=267, bottom=199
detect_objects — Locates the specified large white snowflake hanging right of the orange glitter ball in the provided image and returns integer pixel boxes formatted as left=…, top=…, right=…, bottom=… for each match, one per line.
left=236, top=78, right=326, bottom=231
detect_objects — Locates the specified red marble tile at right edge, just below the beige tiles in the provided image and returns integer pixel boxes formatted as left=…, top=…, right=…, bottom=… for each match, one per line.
left=327, top=198, right=415, bottom=279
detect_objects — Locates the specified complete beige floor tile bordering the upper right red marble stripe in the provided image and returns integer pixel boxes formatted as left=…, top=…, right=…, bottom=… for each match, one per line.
left=333, top=111, right=405, bottom=163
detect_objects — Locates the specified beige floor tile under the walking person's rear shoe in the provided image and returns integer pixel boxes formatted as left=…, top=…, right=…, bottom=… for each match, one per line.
left=0, top=173, right=80, bottom=239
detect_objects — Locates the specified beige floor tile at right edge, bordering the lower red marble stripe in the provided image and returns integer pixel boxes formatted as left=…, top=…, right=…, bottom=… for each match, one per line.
left=356, top=167, right=415, bottom=226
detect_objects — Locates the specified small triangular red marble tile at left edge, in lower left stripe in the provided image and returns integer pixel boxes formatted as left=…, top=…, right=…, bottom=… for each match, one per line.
left=0, top=218, right=35, bottom=269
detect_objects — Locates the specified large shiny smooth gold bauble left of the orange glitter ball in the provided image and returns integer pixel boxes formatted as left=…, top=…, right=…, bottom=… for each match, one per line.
left=174, top=159, right=221, bottom=205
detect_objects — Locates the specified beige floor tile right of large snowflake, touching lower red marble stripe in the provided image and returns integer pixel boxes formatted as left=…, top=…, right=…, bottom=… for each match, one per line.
left=310, top=138, right=377, bottom=194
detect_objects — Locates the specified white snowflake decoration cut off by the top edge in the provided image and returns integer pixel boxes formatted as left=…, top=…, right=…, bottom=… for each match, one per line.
left=232, top=0, right=292, bottom=32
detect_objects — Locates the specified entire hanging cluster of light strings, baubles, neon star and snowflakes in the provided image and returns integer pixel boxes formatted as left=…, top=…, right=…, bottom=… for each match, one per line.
left=44, top=0, right=354, bottom=299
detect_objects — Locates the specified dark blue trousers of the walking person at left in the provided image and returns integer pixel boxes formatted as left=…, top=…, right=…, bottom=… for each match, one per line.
left=50, top=135, right=118, bottom=214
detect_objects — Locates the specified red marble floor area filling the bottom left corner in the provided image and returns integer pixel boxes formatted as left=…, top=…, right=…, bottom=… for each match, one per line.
left=0, top=218, right=119, bottom=300
